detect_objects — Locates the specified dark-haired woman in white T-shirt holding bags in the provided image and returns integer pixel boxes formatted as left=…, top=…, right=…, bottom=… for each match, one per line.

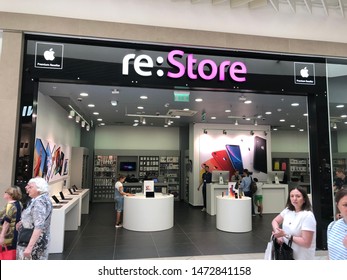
left=272, top=187, right=317, bottom=260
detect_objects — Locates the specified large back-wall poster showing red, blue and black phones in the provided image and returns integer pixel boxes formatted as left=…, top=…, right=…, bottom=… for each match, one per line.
left=200, top=131, right=268, bottom=181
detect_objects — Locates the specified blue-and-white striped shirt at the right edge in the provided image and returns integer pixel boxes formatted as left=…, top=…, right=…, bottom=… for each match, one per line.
left=327, top=219, right=347, bottom=260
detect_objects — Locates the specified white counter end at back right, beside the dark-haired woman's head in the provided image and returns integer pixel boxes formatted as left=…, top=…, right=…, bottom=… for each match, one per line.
left=264, top=184, right=288, bottom=214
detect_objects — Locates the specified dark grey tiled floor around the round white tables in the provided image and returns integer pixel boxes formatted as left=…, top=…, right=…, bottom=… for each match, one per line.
left=49, top=202, right=327, bottom=260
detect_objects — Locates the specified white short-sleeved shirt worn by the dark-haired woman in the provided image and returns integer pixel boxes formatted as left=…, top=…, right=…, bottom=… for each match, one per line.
left=280, top=208, right=317, bottom=260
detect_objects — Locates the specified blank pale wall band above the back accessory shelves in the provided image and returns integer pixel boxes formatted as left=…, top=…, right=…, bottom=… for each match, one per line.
left=95, top=126, right=180, bottom=150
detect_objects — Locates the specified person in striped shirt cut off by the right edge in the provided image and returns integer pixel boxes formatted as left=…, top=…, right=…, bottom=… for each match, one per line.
left=327, top=189, right=347, bottom=260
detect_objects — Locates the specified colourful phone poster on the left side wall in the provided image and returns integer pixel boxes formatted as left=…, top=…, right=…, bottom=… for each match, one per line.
left=33, top=138, right=71, bottom=182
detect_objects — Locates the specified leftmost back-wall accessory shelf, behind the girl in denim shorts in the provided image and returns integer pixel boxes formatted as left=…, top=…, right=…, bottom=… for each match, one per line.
left=92, top=155, right=117, bottom=202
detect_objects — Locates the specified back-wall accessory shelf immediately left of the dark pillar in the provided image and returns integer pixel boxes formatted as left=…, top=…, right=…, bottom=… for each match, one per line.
left=160, top=156, right=180, bottom=200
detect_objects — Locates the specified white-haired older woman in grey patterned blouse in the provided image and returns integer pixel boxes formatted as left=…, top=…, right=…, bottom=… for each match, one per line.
left=17, top=177, right=52, bottom=260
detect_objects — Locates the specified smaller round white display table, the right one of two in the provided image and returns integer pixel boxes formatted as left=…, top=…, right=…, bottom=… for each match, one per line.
left=216, top=195, right=252, bottom=232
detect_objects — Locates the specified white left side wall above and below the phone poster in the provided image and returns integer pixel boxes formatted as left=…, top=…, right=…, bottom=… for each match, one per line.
left=36, top=93, right=80, bottom=194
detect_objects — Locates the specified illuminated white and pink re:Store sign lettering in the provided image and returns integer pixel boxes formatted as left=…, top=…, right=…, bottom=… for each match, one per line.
left=122, top=50, right=247, bottom=83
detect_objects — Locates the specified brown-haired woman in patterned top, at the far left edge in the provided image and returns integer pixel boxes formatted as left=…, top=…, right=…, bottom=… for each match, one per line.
left=0, top=187, right=23, bottom=250
